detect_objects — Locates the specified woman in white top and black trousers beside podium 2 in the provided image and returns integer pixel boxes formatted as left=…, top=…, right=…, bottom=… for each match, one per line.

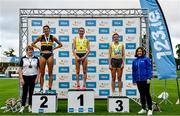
left=19, top=46, right=39, bottom=113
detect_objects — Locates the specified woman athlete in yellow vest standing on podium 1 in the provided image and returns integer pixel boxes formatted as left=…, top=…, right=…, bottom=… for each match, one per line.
left=72, top=27, right=90, bottom=89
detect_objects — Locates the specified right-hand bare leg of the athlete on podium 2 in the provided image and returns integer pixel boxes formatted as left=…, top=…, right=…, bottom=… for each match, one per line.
left=47, top=56, right=54, bottom=89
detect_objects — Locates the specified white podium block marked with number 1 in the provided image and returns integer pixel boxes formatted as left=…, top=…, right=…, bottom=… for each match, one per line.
left=68, top=89, right=94, bottom=113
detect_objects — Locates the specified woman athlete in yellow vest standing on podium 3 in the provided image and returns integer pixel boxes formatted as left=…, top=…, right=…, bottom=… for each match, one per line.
left=109, top=33, right=124, bottom=96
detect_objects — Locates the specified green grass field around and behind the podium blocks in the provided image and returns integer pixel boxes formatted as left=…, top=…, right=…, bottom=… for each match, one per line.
left=0, top=74, right=180, bottom=115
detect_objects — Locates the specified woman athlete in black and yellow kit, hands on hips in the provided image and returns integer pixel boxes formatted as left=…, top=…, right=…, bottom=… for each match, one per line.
left=32, top=25, right=62, bottom=93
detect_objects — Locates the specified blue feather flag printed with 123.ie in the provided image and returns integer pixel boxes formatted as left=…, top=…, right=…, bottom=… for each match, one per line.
left=140, top=0, right=177, bottom=79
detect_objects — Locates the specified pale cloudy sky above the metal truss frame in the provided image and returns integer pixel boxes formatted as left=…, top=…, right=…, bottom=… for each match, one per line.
left=0, top=0, right=180, bottom=57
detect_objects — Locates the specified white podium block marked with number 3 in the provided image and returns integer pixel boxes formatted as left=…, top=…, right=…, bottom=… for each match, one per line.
left=108, top=96, right=129, bottom=113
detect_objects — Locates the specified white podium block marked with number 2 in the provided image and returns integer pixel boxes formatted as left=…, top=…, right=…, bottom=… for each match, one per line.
left=32, top=94, right=58, bottom=113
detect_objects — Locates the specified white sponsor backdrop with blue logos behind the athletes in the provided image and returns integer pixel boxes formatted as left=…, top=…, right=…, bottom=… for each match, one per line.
left=28, top=18, right=140, bottom=98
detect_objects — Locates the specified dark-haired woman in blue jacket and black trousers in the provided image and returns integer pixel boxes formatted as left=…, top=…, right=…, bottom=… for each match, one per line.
left=132, top=47, right=152, bottom=115
